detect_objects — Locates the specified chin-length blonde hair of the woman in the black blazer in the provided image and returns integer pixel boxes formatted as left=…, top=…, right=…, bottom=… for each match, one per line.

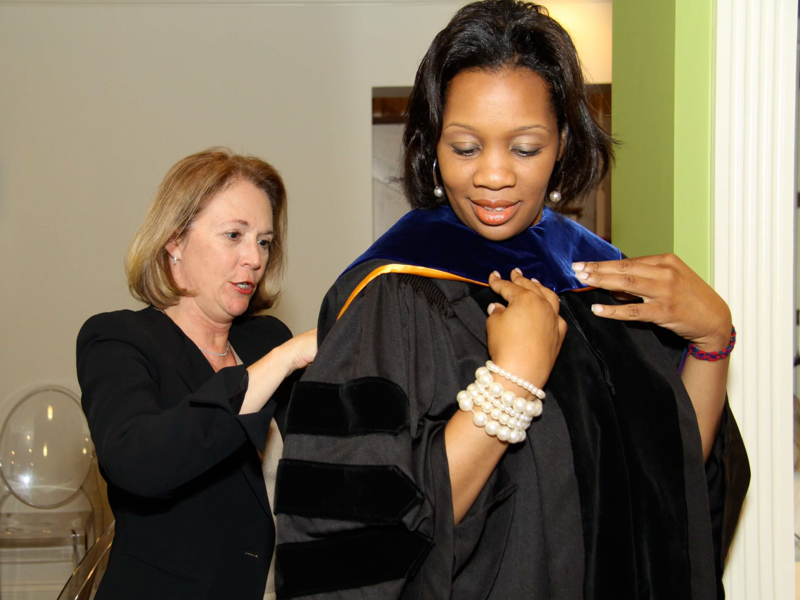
left=125, top=147, right=286, bottom=314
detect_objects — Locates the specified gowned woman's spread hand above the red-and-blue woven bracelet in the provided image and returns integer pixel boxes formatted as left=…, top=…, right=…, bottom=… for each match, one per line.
left=572, top=254, right=731, bottom=351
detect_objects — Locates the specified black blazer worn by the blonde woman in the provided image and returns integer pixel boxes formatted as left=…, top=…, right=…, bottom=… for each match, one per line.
left=77, top=308, right=291, bottom=600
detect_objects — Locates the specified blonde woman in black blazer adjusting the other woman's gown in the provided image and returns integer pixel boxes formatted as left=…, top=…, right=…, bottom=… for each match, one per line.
left=78, top=149, right=316, bottom=600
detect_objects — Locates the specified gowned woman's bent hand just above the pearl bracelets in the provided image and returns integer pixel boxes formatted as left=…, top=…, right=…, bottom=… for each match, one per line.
left=486, top=269, right=567, bottom=388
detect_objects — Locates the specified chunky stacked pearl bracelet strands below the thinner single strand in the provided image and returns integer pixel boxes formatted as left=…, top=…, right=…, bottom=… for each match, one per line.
left=456, top=367, right=542, bottom=444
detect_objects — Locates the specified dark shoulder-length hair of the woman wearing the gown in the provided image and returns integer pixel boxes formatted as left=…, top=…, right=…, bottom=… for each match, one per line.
left=403, top=0, right=614, bottom=209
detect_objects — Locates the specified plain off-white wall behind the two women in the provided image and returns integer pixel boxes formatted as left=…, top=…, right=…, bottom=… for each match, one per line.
left=0, top=0, right=611, bottom=418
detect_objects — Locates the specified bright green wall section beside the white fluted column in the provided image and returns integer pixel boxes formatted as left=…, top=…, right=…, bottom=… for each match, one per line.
left=611, top=0, right=713, bottom=280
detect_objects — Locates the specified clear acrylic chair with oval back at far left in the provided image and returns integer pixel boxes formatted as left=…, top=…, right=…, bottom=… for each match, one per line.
left=0, top=386, right=102, bottom=587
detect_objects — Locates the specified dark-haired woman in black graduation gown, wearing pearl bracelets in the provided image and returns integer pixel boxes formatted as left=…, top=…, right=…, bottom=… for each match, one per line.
left=275, top=0, right=749, bottom=600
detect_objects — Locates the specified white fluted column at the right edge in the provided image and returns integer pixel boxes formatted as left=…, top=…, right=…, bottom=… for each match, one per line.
left=713, top=0, right=798, bottom=600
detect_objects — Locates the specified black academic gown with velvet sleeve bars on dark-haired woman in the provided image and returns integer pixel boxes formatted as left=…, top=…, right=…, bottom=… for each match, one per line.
left=276, top=209, right=749, bottom=600
